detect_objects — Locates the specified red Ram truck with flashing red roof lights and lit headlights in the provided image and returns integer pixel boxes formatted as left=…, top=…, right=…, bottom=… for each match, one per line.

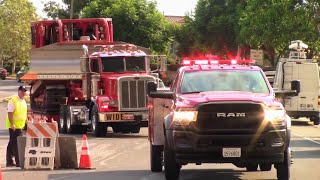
left=148, top=59, right=299, bottom=180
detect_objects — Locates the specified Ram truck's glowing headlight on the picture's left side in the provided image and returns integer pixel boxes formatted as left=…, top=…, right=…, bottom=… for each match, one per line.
left=173, top=109, right=198, bottom=126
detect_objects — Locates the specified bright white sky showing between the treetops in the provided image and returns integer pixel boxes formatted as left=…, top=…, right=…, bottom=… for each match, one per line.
left=29, top=0, right=198, bottom=17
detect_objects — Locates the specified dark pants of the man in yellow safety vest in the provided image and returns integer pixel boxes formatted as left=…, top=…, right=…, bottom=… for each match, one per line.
left=7, top=128, right=22, bottom=165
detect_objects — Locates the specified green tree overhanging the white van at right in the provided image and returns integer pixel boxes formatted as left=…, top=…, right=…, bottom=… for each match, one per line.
left=239, top=0, right=320, bottom=64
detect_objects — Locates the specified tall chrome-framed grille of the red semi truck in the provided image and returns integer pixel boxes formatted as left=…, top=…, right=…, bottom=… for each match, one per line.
left=119, top=77, right=153, bottom=111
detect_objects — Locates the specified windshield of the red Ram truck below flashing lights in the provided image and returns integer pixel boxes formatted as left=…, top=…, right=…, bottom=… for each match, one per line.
left=180, top=70, right=269, bottom=94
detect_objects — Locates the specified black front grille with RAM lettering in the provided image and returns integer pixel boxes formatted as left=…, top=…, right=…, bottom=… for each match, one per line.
left=196, top=102, right=263, bottom=132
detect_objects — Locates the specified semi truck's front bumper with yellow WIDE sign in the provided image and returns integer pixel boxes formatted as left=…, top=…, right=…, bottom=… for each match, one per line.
left=99, top=111, right=148, bottom=123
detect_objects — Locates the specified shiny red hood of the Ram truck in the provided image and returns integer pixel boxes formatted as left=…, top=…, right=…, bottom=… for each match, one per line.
left=176, top=91, right=280, bottom=107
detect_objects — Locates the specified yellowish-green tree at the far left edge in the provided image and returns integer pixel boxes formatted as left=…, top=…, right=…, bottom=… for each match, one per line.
left=0, top=0, right=37, bottom=72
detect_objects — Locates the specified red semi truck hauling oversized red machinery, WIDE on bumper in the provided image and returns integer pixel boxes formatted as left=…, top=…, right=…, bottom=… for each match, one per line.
left=21, top=18, right=166, bottom=136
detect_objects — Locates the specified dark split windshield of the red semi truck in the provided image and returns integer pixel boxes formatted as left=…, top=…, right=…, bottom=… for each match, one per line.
left=101, top=57, right=146, bottom=72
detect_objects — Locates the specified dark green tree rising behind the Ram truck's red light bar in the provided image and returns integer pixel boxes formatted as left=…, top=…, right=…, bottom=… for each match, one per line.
left=177, top=0, right=245, bottom=55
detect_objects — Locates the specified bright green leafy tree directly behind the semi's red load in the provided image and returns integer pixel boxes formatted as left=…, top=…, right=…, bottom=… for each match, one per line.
left=83, top=0, right=174, bottom=53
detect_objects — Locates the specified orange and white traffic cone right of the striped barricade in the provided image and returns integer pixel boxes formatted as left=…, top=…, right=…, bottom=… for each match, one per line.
left=79, top=134, right=95, bottom=169
